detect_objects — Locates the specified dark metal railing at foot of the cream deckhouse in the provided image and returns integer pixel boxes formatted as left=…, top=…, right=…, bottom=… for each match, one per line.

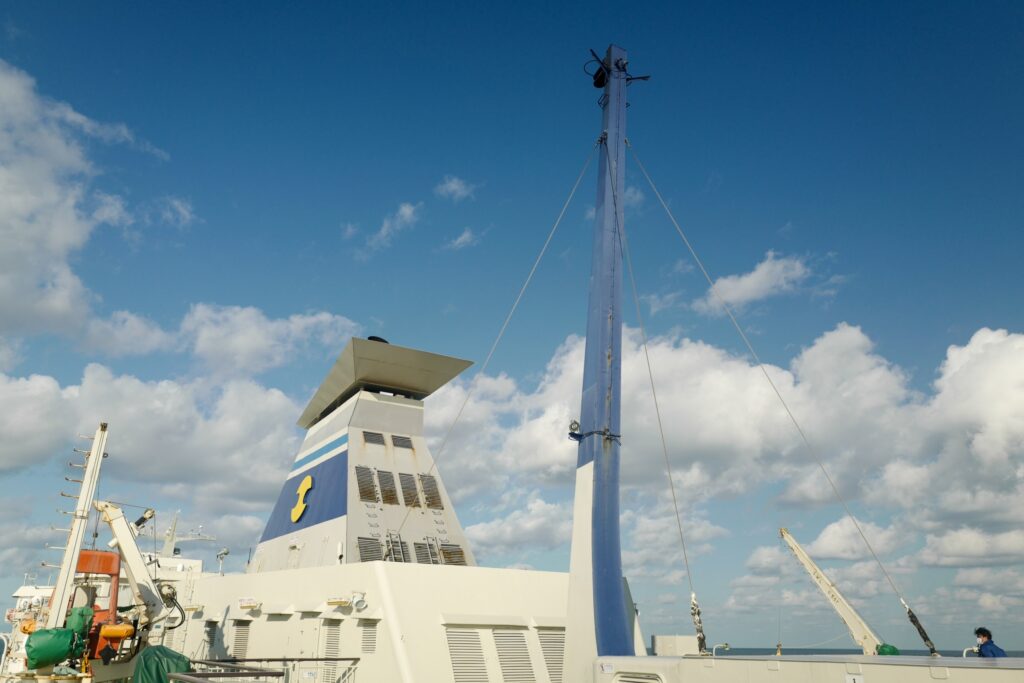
left=182, top=657, right=359, bottom=683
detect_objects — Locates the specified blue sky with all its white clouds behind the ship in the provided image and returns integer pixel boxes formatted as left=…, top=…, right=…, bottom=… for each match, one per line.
left=0, top=2, right=1024, bottom=648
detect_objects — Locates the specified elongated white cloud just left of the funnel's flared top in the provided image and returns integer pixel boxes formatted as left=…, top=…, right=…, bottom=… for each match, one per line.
left=180, top=303, right=359, bottom=375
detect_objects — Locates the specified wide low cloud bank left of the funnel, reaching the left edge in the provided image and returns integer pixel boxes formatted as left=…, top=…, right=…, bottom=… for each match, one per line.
left=0, top=365, right=300, bottom=514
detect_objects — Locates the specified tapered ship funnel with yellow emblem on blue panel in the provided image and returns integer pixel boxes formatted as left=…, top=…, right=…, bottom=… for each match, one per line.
left=249, top=339, right=476, bottom=572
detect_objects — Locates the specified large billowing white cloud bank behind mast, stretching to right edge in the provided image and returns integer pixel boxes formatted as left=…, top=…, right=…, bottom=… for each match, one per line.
left=426, top=325, right=1024, bottom=600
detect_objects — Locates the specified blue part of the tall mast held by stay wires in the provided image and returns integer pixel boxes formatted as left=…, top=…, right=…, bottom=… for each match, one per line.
left=573, top=45, right=635, bottom=656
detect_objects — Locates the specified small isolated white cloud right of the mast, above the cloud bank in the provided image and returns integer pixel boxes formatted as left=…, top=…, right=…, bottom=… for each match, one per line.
left=693, top=251, right=811, bottom=315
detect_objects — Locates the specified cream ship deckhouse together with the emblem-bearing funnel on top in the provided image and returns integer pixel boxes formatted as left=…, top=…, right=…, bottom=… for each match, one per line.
left=149, top=339, right=606, bottom=683
